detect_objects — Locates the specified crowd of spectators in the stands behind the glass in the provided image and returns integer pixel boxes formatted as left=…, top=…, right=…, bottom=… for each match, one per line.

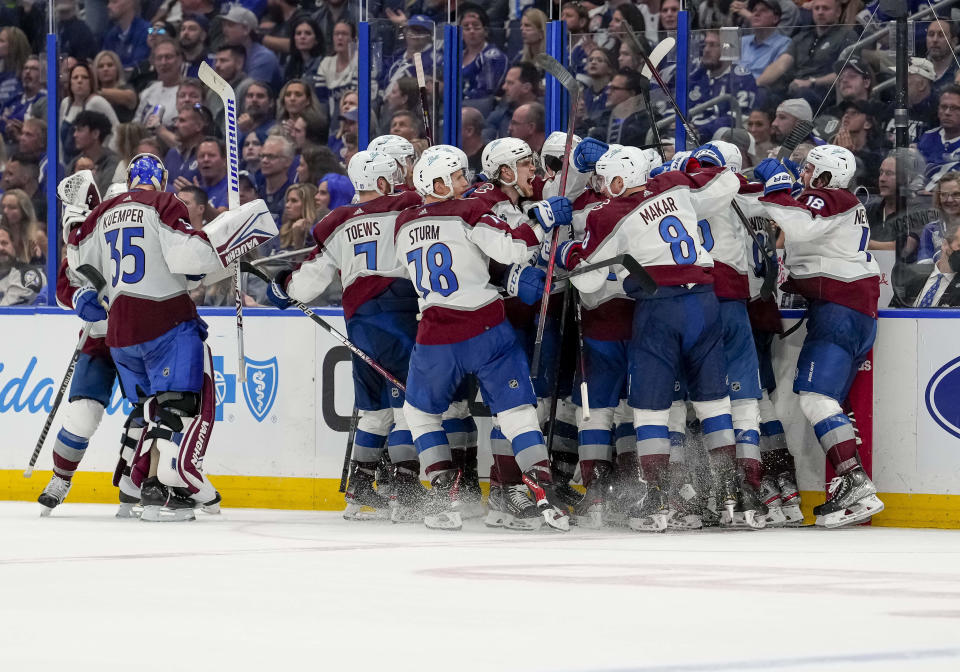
left=0, top=0, right=960, bottom=305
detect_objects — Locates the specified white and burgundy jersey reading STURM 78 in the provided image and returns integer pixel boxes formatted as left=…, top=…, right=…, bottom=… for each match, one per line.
left=396, top=198, right=543, bottom=345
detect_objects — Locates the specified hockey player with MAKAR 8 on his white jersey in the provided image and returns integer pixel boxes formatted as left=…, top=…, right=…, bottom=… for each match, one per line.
left=558, top=146, right=739, bottom=531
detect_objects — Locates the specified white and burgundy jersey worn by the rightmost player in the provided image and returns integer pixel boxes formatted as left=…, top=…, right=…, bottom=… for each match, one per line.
left=760, top=189, right=880, bottom=317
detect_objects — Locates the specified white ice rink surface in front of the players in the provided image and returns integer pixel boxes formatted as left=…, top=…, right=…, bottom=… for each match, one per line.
left=0, top=502, right=960, bottom=672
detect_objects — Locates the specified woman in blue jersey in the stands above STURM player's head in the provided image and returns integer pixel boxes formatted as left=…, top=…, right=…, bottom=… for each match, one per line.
left=460, top=3, right=507, bottom=109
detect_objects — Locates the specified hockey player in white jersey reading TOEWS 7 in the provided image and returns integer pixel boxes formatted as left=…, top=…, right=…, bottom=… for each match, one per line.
left=267, top=150, right=423, bottom=522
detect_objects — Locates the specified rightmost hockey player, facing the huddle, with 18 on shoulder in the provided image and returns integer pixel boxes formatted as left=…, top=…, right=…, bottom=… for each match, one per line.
left=754, top=145, right=883, bottom=527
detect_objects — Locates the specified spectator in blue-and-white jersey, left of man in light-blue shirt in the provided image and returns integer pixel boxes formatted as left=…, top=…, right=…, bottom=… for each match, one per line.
left=689, top=30, right=757, bottom=136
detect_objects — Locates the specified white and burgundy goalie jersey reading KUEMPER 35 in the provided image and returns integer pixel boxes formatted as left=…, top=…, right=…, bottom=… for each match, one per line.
left=67, top=190, right=223, bottom=347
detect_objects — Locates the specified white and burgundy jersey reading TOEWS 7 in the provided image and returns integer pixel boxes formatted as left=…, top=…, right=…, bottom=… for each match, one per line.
left=286, top=191, right=422, bottom=319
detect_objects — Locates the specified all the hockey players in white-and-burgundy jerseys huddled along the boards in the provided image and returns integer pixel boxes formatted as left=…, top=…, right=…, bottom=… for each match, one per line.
left=41, top=126, right=883, bottom=532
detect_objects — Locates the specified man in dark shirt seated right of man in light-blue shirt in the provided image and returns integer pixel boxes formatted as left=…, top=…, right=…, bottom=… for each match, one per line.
left=757, top=0, right=856, bottom=105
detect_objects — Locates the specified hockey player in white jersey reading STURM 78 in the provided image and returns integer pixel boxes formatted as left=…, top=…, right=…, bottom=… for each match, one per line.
left=396, top=155, right=569, bottom=530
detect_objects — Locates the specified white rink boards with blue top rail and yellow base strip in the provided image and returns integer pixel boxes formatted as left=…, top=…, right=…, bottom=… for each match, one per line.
left=0, top=309, right=960, bottom=527
